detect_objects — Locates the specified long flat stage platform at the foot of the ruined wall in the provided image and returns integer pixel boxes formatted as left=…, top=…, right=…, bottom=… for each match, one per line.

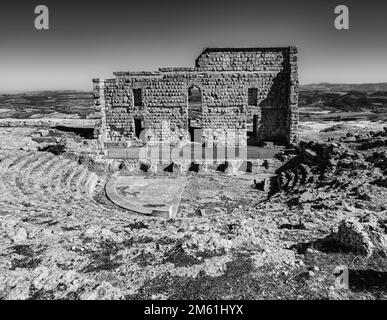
left=106, top=144, right=285, bottom=161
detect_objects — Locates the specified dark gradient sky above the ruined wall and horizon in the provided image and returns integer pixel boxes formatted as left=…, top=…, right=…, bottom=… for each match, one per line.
left=0, top=0, right=387, bottom=92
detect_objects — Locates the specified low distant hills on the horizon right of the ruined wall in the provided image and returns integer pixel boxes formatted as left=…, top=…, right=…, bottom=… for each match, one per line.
left=300, top=82, right=387, bottom=92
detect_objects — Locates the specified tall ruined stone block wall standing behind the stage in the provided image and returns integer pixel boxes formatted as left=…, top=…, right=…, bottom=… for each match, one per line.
left=94, top=47, right=298, bottom=146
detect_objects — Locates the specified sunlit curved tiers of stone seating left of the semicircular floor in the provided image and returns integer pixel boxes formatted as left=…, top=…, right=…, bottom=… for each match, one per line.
left=0, top=152, right=106, bottom=212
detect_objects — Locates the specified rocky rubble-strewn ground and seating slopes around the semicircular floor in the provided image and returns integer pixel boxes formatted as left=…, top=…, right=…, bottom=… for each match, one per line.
left=0, top=128, right=387, bottom=299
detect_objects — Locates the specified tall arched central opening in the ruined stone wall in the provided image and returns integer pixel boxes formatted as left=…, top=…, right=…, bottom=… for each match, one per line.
left=187, top=85, right=202, bottom=142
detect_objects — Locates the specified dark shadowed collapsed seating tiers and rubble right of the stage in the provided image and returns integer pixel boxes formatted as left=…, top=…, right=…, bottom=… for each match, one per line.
left=276, top=129, right=387, bottom=195
